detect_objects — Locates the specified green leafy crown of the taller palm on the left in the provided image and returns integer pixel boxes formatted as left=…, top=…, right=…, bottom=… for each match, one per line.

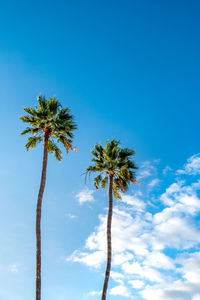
left=20, top=95, right=77, bottom=161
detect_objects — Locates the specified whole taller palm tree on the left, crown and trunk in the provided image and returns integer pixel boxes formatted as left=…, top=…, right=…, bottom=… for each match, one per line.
left=20, top=95, right=77, bottom=300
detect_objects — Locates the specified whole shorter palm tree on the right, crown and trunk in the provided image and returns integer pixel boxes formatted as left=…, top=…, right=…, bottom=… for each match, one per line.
left=86, top=139, right=137, bottom=300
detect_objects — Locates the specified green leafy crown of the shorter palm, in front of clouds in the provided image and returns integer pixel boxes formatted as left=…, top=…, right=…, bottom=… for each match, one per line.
left=87, top=139, right=137, bottom=199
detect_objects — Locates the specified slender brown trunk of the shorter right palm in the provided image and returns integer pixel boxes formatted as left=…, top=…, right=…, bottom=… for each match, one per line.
left=101, top=175, right=113, bottom=300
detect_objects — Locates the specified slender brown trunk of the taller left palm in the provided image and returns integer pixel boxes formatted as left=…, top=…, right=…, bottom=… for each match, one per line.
left=36, top=133, right=49, bottom=300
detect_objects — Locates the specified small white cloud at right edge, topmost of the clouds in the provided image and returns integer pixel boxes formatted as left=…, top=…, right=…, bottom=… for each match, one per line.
left=177, top=153, right=200, bottom=175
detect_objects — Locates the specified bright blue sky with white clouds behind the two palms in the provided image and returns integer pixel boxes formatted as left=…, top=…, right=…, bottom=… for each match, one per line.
left=0, top=0, right=200, bottom=300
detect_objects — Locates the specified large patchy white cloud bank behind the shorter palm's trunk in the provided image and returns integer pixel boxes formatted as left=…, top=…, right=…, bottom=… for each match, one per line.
left=67, top=155, right=200, bottom=300
